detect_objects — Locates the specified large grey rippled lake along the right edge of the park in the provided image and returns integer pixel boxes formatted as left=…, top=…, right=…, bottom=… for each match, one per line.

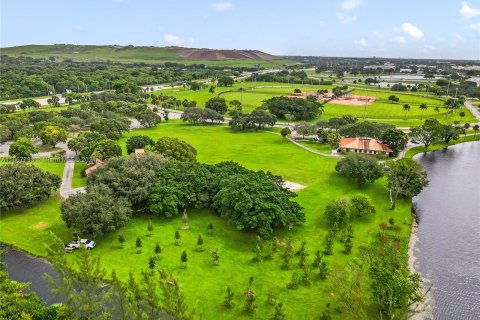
left=414, top=141, right=480, bottom=319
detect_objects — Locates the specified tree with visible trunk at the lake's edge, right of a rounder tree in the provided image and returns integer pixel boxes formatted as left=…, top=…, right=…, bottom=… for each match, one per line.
left=386, top=158, right=428, bottom=210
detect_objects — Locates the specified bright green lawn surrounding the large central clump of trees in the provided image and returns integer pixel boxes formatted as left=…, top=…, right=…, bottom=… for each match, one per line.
left=0, top=124, right=410, bottom=319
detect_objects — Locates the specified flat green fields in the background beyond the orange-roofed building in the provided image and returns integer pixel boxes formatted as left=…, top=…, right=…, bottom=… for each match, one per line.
left=155, top=82, right=476, bottom=127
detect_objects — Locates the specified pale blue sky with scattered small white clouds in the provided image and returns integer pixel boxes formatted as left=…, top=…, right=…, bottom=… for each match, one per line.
left=0, top=0, right=480, bottom=60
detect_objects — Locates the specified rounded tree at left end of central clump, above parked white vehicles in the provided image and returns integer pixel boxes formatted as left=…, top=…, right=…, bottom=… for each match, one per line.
left=61, top=185, right=132, bottom=237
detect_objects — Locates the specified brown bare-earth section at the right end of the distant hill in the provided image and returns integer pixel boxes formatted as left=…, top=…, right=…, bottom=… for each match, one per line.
left=178, top=48, right=277, bottom=60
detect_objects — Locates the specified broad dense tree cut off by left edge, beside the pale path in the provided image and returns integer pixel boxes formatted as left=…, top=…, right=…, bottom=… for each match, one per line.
left=0, top=162, right=61, bottom=211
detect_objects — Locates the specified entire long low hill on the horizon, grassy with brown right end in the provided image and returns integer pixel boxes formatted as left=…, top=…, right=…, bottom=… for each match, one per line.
left=0, top=44, right=292, bottom=65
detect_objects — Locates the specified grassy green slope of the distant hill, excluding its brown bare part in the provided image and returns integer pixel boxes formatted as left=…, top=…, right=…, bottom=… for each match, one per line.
left=2, top=44, right=294, bottom=68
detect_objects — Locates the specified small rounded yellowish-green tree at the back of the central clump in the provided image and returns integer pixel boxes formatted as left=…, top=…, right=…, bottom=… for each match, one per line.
left=152, top=137, right=197, bottom=162
